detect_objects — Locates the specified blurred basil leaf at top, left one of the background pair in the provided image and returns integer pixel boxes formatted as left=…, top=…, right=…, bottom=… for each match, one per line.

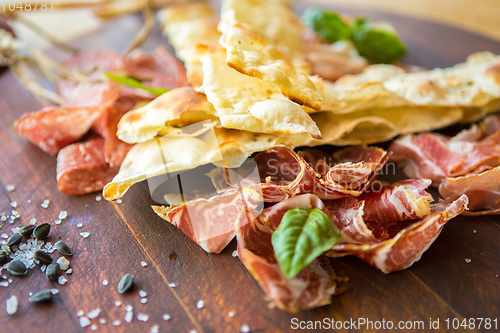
left=301, top=8, right=351, bottom=43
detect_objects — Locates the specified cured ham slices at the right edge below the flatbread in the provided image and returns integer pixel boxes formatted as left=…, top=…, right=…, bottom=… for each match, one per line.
left=389, top=115, right=500, bottom=215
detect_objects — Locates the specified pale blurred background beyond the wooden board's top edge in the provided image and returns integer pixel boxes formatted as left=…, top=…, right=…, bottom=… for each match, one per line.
left=0, top=0, right=500, bottom=47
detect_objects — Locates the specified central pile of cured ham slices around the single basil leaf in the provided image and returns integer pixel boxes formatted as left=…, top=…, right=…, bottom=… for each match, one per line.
left=153, top=146, right=468, bottom=312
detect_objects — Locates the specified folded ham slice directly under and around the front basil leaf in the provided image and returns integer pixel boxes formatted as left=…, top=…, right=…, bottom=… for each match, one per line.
left=237, top=194, right=337, bottom=312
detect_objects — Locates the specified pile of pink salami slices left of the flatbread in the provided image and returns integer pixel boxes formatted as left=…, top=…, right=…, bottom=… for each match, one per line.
left=14, top=47, right=187, bottom=195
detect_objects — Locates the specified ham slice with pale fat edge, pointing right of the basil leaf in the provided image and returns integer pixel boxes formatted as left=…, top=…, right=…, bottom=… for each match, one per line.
left=328, top=195, right=468, bottom=273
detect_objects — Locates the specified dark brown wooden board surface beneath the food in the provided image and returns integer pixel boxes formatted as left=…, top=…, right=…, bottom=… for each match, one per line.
left=0, top=5, right=500, bottom=332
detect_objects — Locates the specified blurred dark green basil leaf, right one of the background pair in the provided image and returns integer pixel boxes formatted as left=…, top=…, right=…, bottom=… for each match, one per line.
left=352, top=18, right=406, bottom=63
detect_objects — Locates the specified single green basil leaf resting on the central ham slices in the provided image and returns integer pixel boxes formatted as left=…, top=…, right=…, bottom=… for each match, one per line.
left=272, top=207, right=340, bottom=279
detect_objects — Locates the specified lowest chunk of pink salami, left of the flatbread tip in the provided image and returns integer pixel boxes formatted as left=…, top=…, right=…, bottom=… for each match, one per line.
left=57, top=137, right=119, bottom=195
